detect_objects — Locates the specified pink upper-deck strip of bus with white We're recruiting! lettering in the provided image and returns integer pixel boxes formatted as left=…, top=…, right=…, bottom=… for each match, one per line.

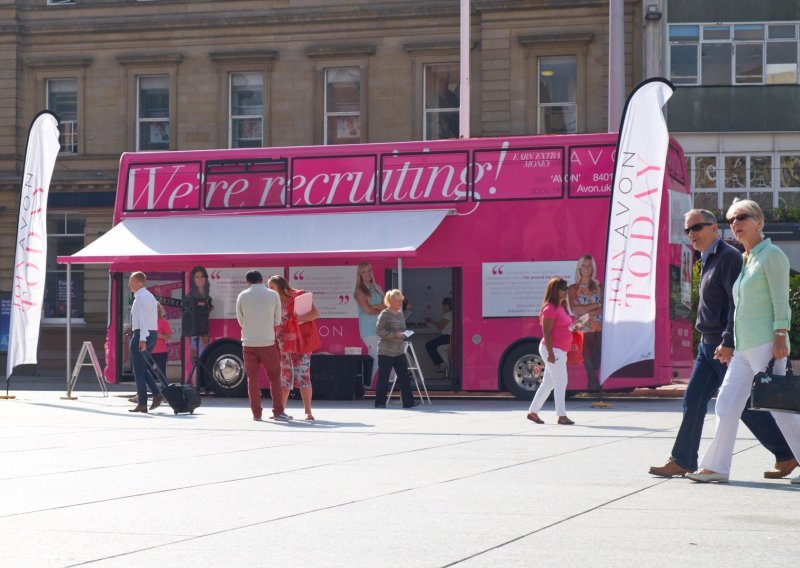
left=125, top=142, right=614, bottom=211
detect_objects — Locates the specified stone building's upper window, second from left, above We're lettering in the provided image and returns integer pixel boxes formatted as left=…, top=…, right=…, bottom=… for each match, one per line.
left=136, top=75, right=169, bottom=150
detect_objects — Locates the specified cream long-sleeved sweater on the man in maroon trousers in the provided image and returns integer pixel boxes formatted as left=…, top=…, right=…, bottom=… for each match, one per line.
left=236, top=283, right=281, bottom=347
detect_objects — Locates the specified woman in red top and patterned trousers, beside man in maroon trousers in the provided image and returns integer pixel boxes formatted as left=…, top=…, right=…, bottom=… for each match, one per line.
left=267, top=275, right=319, bottom=421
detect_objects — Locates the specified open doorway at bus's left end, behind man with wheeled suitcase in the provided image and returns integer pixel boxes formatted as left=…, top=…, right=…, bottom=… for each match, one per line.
left=114, top=272, right=186, bottom=381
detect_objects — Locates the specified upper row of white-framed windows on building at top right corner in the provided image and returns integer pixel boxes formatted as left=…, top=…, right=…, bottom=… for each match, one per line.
left=669, top=22, right=800, bottom=85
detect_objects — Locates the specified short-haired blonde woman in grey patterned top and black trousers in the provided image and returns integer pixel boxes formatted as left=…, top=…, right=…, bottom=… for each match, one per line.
left=375, top=290, right=419, bottom=408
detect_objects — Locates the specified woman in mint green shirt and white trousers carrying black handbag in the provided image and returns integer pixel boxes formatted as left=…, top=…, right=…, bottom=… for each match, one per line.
left=687, top=199, right=800, bottom=484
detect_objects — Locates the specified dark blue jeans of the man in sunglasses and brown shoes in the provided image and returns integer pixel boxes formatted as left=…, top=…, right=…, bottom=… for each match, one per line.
left=672, top=343, right=792, bottom=471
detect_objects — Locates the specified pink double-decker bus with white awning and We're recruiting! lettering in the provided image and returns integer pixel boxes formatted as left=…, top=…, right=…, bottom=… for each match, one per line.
left=59, top=134, right=692, bottom=398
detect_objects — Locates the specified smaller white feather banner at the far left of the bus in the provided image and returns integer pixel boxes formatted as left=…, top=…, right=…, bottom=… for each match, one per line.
left=6, top=111, right=60, bottom=379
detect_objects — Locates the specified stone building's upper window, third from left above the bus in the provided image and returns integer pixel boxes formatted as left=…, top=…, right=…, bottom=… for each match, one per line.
left=228, top=73, right=264, bottom=148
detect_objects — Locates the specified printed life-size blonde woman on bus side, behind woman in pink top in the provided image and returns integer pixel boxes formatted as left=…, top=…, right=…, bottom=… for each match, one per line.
left=567, top=254, right=603, bottom=392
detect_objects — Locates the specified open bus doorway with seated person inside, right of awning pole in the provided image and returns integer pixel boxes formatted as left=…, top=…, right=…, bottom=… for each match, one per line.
left=403, top=268, right=461, bottom=390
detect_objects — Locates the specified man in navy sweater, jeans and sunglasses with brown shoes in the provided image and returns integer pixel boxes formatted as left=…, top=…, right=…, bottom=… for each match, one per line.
left=650, top=209, right=797, bottom=479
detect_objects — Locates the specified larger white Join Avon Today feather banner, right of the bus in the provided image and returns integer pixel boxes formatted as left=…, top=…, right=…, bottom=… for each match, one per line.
left=600, top=78, right=674, bottom=384
